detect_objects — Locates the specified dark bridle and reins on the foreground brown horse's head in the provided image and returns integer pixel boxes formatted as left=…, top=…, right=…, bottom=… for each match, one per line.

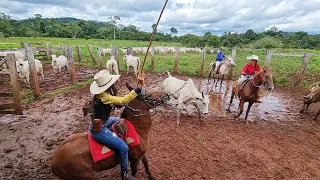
left=125, top=93, right=170, bottom=117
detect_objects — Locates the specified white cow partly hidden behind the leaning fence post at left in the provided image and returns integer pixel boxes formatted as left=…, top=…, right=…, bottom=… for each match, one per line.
left=16, top=59, right=44, bottom=85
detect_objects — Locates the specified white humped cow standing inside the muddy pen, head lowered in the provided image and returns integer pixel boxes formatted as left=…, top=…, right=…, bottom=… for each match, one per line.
left=161, top=72, right=209, bottom=125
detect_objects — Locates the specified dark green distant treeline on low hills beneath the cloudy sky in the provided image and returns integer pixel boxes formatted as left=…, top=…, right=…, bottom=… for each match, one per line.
left=0, top=13, right=320, bottom=49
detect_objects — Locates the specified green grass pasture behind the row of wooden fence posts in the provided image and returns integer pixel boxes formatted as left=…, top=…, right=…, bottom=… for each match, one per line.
left=0, top=37, right=320, bottom=87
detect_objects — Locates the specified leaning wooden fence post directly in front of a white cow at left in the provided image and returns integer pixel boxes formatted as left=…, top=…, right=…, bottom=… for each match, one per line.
left=26, top=45, right=40, bottom=98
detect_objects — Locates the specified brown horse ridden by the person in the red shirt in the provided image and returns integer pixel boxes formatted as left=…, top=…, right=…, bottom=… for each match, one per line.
left=227, top=66, right=274, bottom=122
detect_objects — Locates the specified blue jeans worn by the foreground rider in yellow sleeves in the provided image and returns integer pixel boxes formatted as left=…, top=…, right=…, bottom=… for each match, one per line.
left=90, top=116, right=129, bottom=174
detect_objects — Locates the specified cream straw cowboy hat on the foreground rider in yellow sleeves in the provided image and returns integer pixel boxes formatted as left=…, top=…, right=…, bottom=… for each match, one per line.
left=90, top=69, right=120, bottom=94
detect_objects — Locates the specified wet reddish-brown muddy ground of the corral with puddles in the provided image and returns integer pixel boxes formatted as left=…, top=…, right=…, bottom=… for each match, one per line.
left=0, top=68, right=320, bottom=180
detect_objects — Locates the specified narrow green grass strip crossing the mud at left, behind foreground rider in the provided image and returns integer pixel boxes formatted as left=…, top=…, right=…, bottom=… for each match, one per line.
left=22, top=79, right=92, bottom=104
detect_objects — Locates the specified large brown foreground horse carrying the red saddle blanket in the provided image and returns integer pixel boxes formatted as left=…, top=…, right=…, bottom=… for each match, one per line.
left=51, top=84, right=168, bottom=180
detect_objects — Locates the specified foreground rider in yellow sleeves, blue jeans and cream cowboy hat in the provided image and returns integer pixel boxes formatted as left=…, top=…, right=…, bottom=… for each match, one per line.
left=90, top=70, right=141, bottom=179
